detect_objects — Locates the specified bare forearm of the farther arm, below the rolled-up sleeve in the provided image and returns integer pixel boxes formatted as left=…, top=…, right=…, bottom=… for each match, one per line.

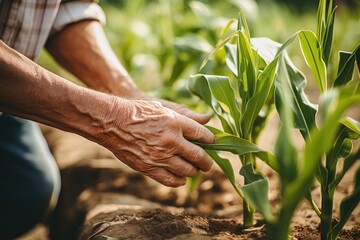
left=46, top=20, right=143, bottom=98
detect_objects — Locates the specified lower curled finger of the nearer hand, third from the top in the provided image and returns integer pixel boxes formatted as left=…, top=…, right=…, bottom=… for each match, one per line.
left=166, top=156, right=199, bottom=177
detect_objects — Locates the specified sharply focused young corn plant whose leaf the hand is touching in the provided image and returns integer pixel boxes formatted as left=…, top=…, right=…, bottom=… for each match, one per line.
left=189, top=13, right=280, bottom=228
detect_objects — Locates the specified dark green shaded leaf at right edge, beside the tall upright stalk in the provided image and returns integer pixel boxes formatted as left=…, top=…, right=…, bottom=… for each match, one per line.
left=334, top=44, right=360, bottom=86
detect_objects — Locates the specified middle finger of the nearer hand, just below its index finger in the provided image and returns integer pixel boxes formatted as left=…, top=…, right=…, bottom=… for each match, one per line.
left=176, top=139, right=213, bottom=172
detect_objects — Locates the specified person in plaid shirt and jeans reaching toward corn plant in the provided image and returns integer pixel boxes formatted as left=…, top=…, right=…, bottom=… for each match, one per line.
left=0, top=0, right=214, bottom=239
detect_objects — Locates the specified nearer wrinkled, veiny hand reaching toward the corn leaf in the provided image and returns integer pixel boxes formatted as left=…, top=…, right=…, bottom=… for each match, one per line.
left=105, top=100, right=214, bottom=187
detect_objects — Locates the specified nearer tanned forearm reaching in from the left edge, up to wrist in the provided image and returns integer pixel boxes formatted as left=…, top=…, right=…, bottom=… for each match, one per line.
left=0, top=41, right=124, bottom=142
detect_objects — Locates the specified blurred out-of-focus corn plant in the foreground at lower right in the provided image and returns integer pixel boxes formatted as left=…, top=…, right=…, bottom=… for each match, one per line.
left=240, top=53, right=360, bottom=240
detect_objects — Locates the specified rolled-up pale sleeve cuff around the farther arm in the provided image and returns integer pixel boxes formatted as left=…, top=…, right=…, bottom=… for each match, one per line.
left=50, top=0, right=106, bottom=36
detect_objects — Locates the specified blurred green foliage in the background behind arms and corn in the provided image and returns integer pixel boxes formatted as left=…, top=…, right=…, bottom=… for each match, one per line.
left=38, top=0, right=360, bottom=105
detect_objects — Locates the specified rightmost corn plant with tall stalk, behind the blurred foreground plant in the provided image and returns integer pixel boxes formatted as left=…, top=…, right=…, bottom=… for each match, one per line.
left=272, top=0, right=360, bottom=240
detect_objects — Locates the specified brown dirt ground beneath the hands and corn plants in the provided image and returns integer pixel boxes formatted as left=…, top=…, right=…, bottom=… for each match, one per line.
left=19, top=115, right=360, bottom=240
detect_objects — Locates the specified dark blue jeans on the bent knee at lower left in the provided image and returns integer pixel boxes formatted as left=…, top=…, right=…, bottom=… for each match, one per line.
left=0, top=114, right=60, bottom=239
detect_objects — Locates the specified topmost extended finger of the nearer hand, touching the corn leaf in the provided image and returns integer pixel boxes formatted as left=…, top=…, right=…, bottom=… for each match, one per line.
left=178, top=115, right=215, bottom=143
